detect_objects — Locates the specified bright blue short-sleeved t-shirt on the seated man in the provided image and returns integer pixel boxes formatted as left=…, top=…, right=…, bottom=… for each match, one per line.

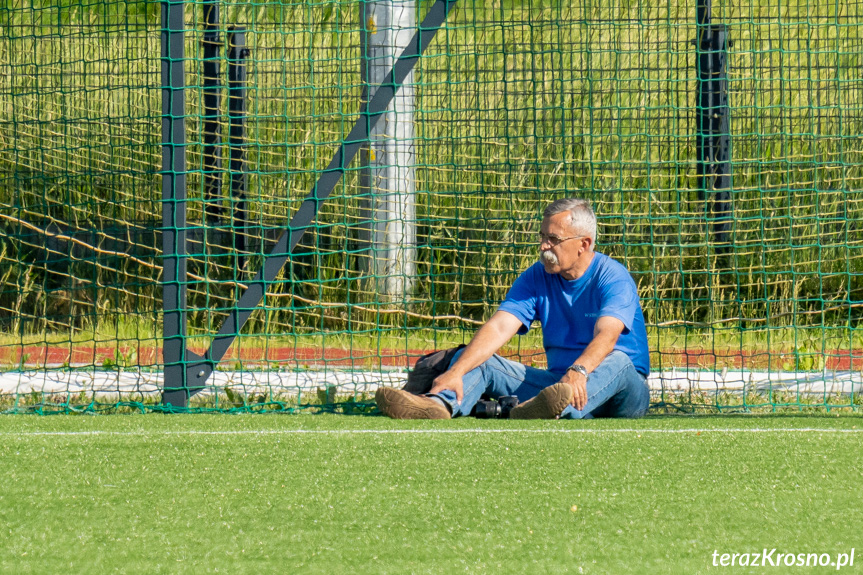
left=500, top=253, right=650, bottom=375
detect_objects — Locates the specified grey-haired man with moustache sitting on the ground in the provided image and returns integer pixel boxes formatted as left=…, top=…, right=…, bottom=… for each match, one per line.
left=375, top=199, right=650, bottom=419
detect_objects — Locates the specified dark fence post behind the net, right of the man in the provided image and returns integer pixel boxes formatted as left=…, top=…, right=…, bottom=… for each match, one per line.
left=695, top=0, right=732, bottom=255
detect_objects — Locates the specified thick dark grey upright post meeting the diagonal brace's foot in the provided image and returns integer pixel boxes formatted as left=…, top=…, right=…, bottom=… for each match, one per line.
left=161, top=0, right=189, bottom=407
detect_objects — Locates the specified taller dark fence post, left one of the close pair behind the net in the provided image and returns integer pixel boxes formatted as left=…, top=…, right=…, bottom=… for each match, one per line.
left=203, top=0, right=222, bottom=226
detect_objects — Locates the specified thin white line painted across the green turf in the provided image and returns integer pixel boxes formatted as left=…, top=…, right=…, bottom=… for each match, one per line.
left=0, top=427, right=863, bottom=437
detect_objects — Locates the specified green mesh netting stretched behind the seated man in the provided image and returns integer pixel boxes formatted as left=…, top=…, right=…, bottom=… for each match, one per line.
left=0, top=0, right=863, bottom=412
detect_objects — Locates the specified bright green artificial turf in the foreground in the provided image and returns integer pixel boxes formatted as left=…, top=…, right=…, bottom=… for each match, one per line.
left=0, top=415, right=863, bottom=574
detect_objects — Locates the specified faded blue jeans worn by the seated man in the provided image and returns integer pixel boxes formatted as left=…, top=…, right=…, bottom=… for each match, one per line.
left=437, top=350, right=650, bottom=419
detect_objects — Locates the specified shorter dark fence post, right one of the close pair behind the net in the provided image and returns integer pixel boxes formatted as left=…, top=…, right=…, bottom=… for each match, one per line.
left=228, top=26, right=249, bottom=269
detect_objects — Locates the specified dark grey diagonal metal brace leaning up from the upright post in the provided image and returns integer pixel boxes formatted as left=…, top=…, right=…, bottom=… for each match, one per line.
left=164, top=0, right=457, bottom=402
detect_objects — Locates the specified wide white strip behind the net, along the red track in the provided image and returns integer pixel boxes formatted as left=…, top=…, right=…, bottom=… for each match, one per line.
left=0, top=369, right=863, bottom=397
